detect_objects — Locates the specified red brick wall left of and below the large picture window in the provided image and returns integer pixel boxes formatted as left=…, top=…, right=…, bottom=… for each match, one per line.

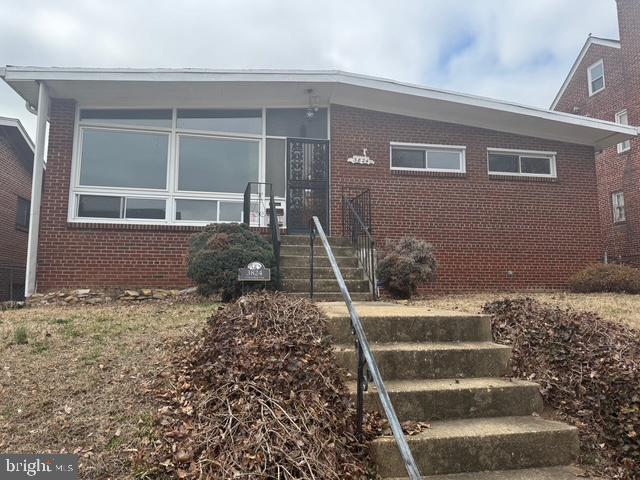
left=38, top=99, right=197, bottom=291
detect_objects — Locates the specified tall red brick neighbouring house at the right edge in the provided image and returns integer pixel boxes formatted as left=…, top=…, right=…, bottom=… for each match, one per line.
left=551, top=0, right=640, bottom=266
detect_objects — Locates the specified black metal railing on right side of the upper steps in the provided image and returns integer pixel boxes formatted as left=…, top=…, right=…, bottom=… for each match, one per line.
left=342, top=190, right=378, bottom=300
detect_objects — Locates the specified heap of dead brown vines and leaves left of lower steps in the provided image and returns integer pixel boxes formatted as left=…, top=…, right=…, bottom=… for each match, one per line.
left=146, top=293, right=379, bottom=480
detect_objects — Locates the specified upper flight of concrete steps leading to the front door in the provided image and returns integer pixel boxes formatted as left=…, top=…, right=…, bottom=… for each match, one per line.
left=280, top=235, right=371, bottom=301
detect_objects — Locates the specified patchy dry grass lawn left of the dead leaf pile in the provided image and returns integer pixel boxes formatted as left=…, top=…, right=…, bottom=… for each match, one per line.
left=0, top=302, right=216, bottom=480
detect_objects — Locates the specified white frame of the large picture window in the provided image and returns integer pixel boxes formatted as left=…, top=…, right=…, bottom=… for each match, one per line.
left=67, top=104, right=331, bottom=226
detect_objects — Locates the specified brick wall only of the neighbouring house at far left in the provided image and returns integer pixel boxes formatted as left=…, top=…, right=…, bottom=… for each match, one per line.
left=0, top=128, right=31, bottom=301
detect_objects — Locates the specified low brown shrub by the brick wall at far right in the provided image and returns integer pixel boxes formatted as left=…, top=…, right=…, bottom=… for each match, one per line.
left=569, top=263, right=640, bottom=293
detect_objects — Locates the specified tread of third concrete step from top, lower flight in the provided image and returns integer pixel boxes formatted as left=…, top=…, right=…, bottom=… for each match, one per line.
left=347, top=377, right=539, bottom=395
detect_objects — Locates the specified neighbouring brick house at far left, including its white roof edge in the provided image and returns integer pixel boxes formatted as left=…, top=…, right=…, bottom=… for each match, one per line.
left=0, top=117, right=33, bottom=302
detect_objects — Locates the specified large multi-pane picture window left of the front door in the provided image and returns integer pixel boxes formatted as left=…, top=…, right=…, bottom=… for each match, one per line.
left=69, top=108, right=328, bottom=225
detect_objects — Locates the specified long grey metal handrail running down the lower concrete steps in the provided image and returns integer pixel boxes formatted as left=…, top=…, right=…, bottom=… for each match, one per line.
left=309, top=216, right=422, bottom=480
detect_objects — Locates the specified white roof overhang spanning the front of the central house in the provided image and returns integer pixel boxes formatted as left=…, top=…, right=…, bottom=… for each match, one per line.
left=0, top=66, right=638, bottom=148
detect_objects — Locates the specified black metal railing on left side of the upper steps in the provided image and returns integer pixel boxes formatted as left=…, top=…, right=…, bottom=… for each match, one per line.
left=242, top=182, right=282, bottom=290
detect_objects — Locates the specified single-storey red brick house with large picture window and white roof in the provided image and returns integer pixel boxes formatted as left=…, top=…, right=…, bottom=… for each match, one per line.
left=0, top=66, right=637, bottom=293
